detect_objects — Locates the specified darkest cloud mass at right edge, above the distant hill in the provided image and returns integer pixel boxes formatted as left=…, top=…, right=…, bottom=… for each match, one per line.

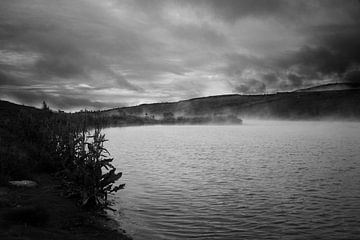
left=286, top=22, right=360, bottom=78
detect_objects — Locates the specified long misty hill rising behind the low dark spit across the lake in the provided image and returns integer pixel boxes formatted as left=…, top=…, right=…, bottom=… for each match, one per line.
left=102, top=86, right=360, bottom=120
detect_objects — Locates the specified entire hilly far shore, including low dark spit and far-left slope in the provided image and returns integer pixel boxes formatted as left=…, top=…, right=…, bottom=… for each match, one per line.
left=0, top=83, right=360, bottom=122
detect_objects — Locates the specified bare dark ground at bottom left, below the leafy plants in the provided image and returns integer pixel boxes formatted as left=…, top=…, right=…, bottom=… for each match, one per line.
left=0, top=174, right=131, bottom=240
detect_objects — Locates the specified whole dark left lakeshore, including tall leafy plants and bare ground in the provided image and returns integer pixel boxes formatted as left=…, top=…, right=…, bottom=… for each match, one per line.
left=0, top=101, right=130, bottom=240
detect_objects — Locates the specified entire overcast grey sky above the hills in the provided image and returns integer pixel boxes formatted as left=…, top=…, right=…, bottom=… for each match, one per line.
left=0, top=0, right=360, bottom=110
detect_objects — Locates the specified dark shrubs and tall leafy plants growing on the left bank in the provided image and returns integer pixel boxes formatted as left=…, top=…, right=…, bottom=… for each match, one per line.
left=0, top=102, right=124, bottom=209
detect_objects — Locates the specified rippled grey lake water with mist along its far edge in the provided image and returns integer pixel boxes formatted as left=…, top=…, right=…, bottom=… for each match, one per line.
left=105, top=121, right=360, bottom=240
